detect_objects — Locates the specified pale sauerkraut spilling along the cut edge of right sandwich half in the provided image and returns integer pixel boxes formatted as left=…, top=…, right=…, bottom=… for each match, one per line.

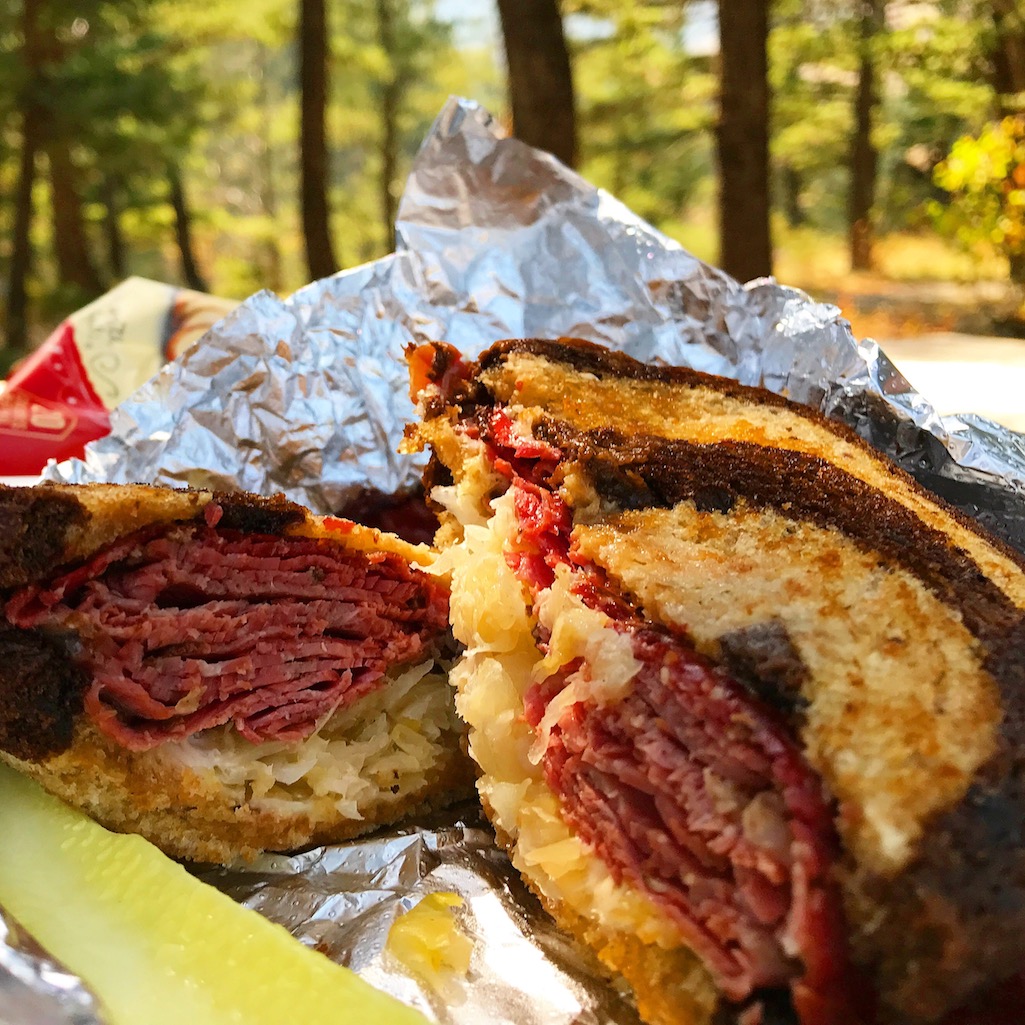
left=445, top=493, right=680, bottom=947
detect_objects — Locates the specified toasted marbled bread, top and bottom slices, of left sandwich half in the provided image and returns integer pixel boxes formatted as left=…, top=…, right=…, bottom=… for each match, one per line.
left=0, top=484, right=475, bottom=863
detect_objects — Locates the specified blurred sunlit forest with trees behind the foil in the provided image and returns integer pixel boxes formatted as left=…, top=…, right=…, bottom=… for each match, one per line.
left=0, top=0, right=1025, bottom=372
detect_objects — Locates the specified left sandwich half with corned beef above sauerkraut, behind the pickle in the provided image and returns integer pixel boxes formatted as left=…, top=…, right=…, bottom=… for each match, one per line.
left=0, top=485, right=473, bottom=862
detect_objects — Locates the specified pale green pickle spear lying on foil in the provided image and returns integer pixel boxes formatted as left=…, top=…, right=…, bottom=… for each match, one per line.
left=0, top=765, right=425, bottom=1025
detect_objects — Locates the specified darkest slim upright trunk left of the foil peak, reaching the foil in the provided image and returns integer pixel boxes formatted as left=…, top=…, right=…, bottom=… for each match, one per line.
left=299, top=0, right=338, bottom=279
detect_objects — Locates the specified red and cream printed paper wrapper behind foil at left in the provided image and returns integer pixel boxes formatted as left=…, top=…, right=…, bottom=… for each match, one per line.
left=0, top=278, right=237, bottom=477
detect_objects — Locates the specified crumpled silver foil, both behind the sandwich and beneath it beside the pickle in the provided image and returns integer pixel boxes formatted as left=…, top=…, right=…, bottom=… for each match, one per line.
left=9, top=99, right=1025, bottom=1025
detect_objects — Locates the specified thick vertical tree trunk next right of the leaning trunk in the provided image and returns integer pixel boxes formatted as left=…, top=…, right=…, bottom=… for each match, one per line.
left=716, top=0, right=772, bottom=281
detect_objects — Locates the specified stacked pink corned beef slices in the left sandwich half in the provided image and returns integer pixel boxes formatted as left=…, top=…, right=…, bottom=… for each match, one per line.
left=6, top=521, right=448, bottom=750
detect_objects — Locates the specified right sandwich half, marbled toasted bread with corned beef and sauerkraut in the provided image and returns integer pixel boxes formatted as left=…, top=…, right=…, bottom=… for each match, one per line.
left=411, top=339, right=1025, bottom=1025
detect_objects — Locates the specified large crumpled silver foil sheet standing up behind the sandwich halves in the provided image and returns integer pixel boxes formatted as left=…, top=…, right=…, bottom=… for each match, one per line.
left=45, top=99, right=1025, bottom=548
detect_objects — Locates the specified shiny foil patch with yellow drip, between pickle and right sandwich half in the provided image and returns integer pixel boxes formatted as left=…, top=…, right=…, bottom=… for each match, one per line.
left=197, top=805, right=641, bottom=1025
